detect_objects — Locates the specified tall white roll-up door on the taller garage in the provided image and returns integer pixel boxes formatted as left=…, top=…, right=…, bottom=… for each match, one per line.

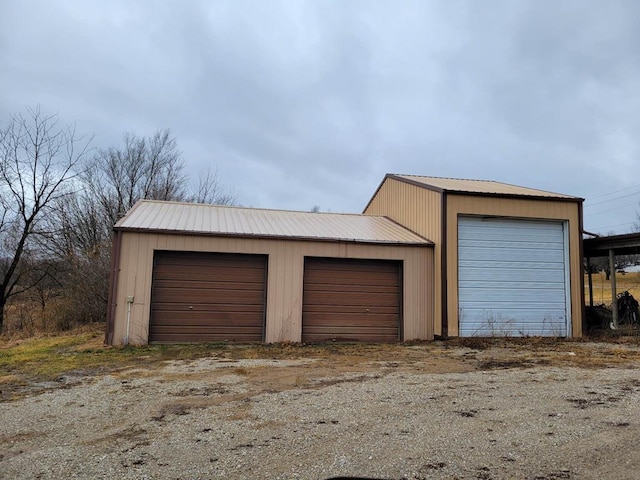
left=458, top=217, right=571, bottom=337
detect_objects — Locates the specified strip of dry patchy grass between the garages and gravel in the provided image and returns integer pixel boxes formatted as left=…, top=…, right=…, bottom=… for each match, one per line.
left=0, top=325, right=640, bottom=401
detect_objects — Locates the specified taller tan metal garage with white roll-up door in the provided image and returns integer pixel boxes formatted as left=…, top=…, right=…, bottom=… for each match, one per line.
left=364, top=174, right=584, bottom=337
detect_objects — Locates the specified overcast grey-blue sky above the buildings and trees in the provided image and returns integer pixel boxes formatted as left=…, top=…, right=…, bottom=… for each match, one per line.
left=0, top=0, right=640, bottom=233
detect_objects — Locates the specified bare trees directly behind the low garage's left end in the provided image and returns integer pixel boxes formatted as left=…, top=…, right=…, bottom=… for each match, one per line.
left=44, top=130, right=234, bottom=328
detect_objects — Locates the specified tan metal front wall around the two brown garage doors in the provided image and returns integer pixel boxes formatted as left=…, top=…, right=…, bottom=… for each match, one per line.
left=113, top=232, right=435, bottom=345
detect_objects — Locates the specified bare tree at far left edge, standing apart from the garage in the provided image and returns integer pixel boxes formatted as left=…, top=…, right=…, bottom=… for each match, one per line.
left=0, top=108, right=91, bottom=331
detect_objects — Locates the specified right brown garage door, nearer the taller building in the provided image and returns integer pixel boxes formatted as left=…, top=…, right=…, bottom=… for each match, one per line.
left=302, top=258, right=401, bottom=342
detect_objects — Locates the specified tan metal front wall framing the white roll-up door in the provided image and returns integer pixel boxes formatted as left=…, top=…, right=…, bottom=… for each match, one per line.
left=448, top=194, right=583, bottom=337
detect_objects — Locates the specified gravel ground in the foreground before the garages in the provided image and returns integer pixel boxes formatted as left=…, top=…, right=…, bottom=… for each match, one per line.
left=0, top=347, right=640, bottom=480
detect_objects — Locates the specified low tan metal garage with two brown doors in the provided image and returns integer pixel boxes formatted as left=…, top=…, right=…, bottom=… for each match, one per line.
left=106, top=200, right=435, bottom=345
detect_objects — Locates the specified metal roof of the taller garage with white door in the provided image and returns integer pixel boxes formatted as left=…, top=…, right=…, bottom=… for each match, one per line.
left=387, top=174, right=582, bottom=200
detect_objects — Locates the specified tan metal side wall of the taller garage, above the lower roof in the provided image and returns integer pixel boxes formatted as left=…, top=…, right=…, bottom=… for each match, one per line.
left=364, top=178, right=442, bottom=335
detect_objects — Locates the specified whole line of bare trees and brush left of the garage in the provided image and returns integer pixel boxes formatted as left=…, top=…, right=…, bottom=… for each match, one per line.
left=0, top=109, right=234, bottom=334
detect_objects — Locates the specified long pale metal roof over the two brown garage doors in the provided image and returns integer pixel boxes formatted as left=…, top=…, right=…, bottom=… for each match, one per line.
left=114, top=200, right=432, bottom=245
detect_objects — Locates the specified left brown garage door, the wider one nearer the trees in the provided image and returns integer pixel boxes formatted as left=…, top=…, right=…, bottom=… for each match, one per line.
left=149, top=252, right=267, bottom=342
